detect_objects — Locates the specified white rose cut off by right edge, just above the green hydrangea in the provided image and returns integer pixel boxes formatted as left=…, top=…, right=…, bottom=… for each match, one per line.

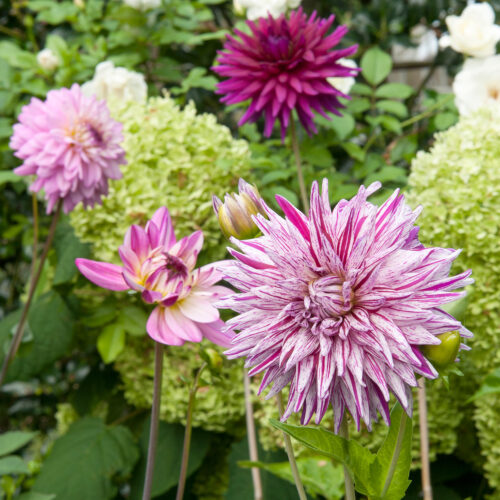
left=453, top=55, right=500, bottom=115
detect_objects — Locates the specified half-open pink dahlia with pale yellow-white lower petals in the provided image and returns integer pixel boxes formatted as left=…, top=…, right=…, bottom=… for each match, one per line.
left=76, top=207, right=233, bottom=346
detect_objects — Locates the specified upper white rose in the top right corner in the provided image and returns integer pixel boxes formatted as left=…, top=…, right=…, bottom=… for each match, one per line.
left=440, top=3, right=500, bottom=57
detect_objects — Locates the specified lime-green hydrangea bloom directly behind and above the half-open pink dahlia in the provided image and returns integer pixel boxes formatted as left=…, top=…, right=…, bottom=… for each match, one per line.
left=71, top=96, right=250, bottom=262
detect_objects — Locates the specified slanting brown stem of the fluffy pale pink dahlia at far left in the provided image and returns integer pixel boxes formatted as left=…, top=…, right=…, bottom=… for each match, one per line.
left=0, top=200, right=62, bottom=387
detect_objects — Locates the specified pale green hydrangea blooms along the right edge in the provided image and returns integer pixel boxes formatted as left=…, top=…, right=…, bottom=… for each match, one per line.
left=409, top=110, right=500, bottom=492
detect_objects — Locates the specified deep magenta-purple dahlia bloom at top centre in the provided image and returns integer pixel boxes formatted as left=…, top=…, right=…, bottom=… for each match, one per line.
left=212, top=8, right=358, bottom=139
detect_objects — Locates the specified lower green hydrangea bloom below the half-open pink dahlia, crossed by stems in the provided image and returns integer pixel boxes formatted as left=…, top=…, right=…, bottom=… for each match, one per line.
left=115, top=338, right=245, bottom=436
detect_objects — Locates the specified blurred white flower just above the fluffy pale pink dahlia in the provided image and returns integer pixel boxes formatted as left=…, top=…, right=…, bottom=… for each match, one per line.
left=82, top=61, right=148, bottom=102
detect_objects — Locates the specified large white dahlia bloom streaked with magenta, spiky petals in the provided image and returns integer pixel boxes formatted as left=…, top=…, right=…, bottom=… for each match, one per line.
left=220, top=179, right=472, bottom=430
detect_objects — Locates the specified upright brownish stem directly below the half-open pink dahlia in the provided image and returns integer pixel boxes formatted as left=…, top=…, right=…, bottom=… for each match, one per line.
left=142, top=342, right=163, bottom=500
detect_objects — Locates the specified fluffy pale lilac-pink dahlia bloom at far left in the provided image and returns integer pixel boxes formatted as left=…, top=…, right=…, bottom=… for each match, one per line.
left=10, top=84, right=126, bottom=213
